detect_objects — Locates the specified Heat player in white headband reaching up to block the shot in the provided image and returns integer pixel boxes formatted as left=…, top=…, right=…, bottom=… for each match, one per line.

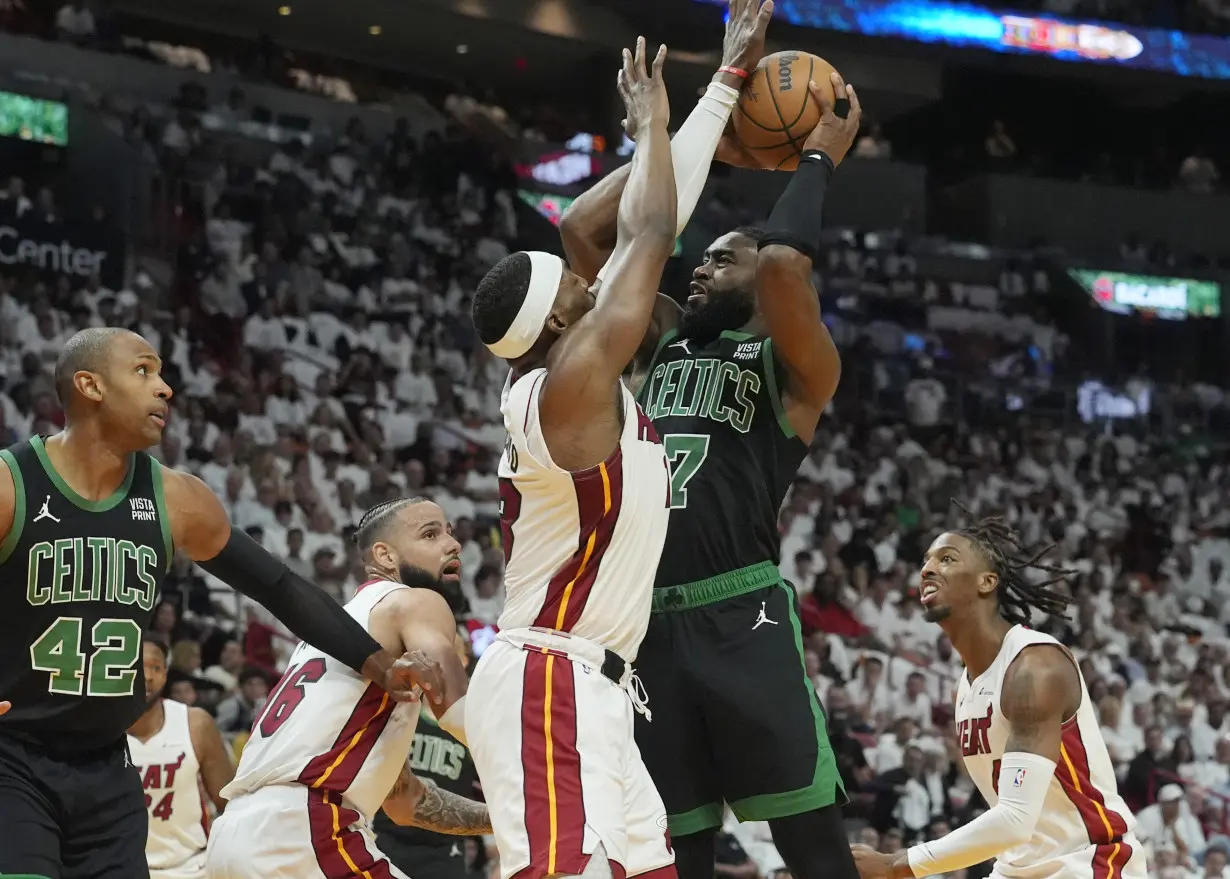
left=464, top=38, right=683, bottom=879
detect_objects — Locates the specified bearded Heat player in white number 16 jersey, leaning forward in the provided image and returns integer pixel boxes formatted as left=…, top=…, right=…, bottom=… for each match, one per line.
left=205, top=498, right=491, bottom=879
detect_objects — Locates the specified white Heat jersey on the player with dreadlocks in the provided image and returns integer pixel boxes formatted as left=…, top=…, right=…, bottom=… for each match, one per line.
left=956, top=626, right=1145, bottom=879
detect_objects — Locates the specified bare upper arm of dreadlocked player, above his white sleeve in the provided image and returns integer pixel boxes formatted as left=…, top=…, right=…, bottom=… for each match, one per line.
left=1000, top=644, right=1081, bottom=763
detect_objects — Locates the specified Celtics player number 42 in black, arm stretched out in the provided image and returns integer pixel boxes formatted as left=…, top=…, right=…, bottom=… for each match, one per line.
left=0, top=328, right=440, bottom=879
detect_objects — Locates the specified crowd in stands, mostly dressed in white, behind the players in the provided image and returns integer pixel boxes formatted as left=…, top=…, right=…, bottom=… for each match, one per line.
left=7, top=0, right=1230, bottom=879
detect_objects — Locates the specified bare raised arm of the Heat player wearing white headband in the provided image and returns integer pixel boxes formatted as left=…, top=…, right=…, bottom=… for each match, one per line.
left=539, top=37, right=677, bottom=430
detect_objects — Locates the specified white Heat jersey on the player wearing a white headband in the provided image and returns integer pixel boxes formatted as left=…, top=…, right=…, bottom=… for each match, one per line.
left=499, top=369, right=670, bottom=661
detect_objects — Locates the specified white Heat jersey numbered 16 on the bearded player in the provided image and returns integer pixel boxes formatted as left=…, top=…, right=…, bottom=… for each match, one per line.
left=223, top=580, right=418, bottom=820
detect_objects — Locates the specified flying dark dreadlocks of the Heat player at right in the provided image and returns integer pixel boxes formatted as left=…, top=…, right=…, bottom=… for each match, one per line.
left=952, top=498, right=1080, bottom=626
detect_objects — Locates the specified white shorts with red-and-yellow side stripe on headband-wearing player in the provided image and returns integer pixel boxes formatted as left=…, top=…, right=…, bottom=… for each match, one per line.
left=465, top=629, right=675, bottom=879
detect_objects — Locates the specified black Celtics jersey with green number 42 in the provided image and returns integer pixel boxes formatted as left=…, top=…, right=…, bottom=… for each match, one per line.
left=0, top=436, right=171, bottom=752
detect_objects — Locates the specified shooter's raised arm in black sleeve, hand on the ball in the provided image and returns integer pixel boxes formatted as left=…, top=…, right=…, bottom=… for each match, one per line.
left=756, top=73, right=862, bottom=441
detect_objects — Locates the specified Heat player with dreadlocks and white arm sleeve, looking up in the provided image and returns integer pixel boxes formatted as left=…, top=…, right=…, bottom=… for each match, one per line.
left=854, top=508, right=1145, bottom=879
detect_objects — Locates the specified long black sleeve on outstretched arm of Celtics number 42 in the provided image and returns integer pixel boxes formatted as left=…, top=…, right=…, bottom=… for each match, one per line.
left=199, top=526, right=381, bottom=674
